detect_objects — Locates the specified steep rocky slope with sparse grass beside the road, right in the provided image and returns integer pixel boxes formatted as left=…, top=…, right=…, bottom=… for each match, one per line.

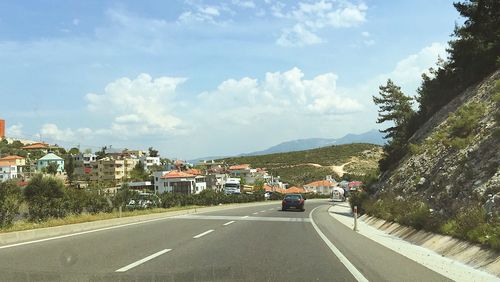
left=372, top=71, right=500, bottom=249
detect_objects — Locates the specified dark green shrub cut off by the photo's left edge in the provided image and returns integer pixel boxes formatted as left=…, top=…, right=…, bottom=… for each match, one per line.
left=0, top=180, right=23, bottom=227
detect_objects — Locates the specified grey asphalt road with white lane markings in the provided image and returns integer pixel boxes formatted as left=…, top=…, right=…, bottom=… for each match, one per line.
left=0, top=200, right=448, bottom=281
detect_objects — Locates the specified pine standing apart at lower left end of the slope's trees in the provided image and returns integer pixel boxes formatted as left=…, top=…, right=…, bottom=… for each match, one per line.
left=373, top=79, right=415, bottom=171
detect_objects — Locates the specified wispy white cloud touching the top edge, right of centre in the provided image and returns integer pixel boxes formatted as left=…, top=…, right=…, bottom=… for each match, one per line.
left=271, top=0, right=368, bottom=46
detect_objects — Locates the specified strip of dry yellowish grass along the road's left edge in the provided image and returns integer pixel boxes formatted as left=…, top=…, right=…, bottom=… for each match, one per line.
left=0, top=206, right=199, bottom=234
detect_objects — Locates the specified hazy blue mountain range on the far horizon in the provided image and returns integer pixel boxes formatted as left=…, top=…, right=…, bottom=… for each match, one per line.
left=188, top=129, right=385, bottom=163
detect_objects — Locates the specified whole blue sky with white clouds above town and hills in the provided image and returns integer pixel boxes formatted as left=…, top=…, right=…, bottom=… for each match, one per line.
left=0, top=0, right=463, bottom=159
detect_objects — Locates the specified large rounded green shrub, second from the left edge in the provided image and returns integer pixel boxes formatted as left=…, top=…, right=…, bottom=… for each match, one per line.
left=24, top=174, right=67, bottom=221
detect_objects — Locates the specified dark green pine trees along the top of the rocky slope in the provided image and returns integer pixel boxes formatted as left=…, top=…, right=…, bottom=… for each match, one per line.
left=373, top=0, right=500, bottom=172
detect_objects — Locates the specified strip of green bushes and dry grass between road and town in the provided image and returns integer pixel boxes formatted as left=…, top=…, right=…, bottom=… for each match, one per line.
left=0, top=175, right=265, bottom=232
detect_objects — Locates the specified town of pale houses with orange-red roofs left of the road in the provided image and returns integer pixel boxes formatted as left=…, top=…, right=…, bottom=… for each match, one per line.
left=0, top=120, right=361, bottom=196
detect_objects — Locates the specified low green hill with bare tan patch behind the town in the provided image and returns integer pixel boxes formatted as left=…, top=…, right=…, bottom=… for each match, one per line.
left=221, top=143, right=382, bottom=186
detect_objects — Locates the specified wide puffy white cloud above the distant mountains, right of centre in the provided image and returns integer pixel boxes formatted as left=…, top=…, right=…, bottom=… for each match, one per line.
left=199, top=68, right=362, bottom=124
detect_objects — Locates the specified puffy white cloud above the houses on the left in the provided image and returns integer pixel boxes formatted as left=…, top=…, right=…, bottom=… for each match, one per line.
left=85, top=73, right=186, bottom=136
